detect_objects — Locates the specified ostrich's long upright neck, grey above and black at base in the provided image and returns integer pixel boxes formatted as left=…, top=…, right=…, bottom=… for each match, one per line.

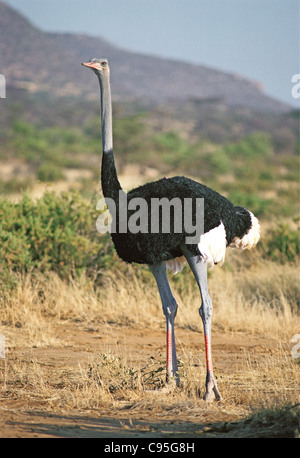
left=99, top=76, right=121, bottom=202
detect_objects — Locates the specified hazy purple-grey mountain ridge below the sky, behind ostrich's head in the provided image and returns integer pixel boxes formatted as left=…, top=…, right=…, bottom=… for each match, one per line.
left=0, top=2, right=290, bottom=113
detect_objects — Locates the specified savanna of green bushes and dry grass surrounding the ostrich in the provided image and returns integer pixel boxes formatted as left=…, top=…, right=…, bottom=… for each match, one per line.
left=0, top=91, right=300, bottom=437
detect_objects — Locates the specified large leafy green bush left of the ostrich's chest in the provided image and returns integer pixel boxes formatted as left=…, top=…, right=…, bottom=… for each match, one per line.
left=0, top=192, right=114, bottom=278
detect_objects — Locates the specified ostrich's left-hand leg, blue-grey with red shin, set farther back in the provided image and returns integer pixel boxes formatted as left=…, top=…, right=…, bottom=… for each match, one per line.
left=149, top=262, right=179, bottom=385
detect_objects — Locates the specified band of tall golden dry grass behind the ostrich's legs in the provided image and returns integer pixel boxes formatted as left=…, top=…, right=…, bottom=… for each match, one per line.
left=1, top=250, right=300, bottom=340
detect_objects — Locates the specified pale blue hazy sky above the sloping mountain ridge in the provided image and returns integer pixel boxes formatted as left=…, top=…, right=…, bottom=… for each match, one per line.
left=4, top=0, right=300, bottom=105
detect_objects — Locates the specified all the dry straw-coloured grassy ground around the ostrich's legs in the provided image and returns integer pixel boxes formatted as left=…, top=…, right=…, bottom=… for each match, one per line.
left=0, top=253, right=300, bottom=435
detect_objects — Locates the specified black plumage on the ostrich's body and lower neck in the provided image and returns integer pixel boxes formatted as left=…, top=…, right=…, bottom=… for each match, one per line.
left=102, top=152, right=251, bottom=265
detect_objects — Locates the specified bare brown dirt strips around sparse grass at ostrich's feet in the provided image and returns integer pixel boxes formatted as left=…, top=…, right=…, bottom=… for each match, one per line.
left=0, top=316, right=298, bottom=439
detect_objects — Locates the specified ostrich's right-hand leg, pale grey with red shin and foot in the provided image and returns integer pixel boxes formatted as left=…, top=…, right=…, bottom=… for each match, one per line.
left=182, top=247, right=222, bottom=401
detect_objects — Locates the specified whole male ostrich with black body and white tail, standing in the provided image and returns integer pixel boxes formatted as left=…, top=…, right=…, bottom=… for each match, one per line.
left=82, top=59, right=260, bottom=400
